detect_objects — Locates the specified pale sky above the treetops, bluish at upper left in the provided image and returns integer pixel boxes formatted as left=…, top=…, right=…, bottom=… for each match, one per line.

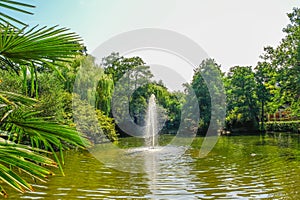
left=9, top=0, right=300, bottom=88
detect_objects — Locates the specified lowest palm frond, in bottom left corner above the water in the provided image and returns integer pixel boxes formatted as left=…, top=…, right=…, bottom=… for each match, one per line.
left=0, top=140, right=57, bottom=196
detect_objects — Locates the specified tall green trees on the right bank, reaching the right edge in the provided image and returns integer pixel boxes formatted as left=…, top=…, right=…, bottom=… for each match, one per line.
left=225, top=8, right=300, bottom=130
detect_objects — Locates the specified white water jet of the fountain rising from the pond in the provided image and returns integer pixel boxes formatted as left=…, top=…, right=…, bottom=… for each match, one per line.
left=145, top=94, right=158, bottom=149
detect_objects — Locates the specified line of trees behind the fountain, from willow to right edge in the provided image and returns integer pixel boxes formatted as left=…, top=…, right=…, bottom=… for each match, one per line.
left=84, top=8, right=300, bottom=135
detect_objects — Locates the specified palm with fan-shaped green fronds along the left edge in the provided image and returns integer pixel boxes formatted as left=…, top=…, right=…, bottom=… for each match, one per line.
left=0, top=0, right=88, bottom=197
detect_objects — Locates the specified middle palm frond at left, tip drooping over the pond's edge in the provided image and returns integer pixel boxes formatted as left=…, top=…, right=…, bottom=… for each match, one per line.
left=0, top=107, right=90, bottom=175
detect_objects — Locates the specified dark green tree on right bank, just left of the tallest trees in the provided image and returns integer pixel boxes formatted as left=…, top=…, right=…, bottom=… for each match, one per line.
left=225, top=66, right=259, bottom=130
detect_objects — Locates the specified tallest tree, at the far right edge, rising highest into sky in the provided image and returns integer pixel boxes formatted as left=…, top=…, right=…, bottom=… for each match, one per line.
left=261, top=8, right=300, bottom=117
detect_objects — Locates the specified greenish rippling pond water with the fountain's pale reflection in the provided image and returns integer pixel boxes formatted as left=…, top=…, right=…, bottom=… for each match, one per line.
left=6, top=133, right=300, bottom=200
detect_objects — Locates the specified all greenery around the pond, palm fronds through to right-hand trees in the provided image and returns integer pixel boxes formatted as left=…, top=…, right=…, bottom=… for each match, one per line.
left=0, top=1, right=300, bottom=196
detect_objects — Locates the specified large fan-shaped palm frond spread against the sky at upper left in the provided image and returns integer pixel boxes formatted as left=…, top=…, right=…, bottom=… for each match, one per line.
left=0, top=26, right=83, bottom=74
